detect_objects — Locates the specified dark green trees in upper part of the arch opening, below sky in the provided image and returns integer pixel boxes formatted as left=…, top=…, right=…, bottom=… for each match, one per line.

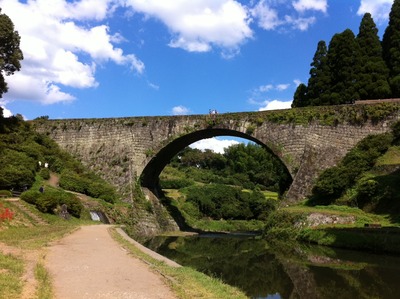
left=167, top=143, right=291, bottom=193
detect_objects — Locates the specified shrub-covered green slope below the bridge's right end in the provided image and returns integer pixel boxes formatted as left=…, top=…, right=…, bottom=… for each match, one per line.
left=309, top=122, right=400, bottom=218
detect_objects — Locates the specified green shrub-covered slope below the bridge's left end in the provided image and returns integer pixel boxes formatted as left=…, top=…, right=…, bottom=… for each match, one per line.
left=0, top=108, right=117, bottom=217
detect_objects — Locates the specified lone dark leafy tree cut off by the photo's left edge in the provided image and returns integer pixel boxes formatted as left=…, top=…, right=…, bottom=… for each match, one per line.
left=0, top=8, right=24, bottom=98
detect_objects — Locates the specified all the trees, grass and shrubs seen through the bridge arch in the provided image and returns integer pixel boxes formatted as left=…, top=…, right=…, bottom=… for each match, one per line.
left=160, top=143, right=291, bottom=226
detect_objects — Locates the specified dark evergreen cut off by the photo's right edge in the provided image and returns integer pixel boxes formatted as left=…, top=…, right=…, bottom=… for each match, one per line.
left=382, top=0, right=400, bottom=98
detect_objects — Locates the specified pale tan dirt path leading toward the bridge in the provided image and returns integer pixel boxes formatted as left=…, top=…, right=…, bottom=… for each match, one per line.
left=46, top=225, right=176, bottom=299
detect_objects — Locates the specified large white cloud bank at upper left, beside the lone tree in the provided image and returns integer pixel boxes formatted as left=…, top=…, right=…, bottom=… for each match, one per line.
left=0, top=0, right=144, bottom=104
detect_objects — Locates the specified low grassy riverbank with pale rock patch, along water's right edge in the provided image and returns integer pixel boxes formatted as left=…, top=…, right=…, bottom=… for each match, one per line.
left=264, top=205, right=400, bottom=254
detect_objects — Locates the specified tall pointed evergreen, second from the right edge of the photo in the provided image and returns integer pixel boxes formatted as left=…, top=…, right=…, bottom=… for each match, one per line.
left=356, top=13, right=391, bottom=100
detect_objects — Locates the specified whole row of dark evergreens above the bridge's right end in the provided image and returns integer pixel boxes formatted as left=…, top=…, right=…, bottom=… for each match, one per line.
left=292, top=0, right=400, bottom=107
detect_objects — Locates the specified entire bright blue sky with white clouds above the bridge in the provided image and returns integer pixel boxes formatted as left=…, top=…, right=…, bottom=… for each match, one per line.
left=0, top=0, right=393, bottom=151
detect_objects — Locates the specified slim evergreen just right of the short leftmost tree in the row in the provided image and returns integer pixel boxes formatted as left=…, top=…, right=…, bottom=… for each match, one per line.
left=307, top=40, right=331, bottom=106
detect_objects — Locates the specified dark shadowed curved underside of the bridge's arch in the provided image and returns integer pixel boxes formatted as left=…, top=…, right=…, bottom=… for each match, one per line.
left=140, top=128, right=293, bottom=190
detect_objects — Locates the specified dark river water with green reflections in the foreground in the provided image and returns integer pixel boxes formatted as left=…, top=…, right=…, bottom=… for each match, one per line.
left=145, top=234, right=400, bottom=299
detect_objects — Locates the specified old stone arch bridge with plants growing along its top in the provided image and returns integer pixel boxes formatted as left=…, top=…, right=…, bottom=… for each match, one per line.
left=33, top=103, right=400, bottom=202
